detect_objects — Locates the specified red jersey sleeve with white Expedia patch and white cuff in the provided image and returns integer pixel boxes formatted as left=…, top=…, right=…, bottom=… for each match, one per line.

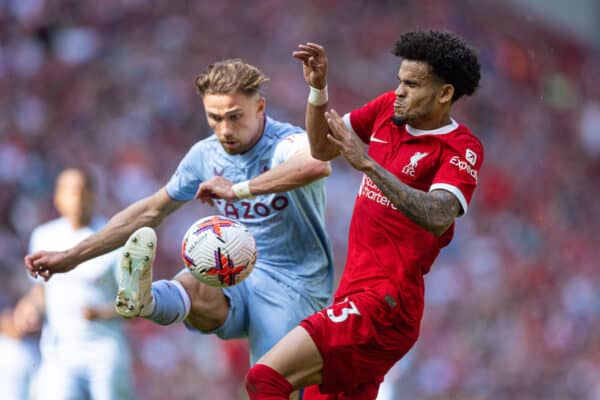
left=429, top=128, right=483, bottom=215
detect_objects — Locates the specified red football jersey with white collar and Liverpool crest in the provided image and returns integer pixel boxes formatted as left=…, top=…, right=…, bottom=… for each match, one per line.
left=336, top=91, right=483, bottom=335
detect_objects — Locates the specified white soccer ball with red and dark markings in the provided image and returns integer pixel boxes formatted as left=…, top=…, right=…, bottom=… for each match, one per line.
left=181, top=215, right=256, bottom=287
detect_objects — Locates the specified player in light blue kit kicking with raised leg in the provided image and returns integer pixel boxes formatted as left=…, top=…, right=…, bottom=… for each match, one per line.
left=25, top=60, right=333, bottom=363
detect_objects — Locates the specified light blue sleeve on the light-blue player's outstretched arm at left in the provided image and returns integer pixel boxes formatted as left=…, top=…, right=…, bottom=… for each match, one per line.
left=166, top=142, right=205, bottom=201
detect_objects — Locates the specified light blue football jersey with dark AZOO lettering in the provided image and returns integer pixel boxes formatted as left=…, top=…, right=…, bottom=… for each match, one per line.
left=166, top=117, right=333, bottom=303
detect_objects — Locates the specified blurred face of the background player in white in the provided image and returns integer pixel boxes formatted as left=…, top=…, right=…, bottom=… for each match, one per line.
left=54, top=170, right=94, bottom=227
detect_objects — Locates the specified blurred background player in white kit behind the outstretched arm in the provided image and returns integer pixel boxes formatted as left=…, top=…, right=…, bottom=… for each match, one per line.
left=22, top=169, right=133, bottom=400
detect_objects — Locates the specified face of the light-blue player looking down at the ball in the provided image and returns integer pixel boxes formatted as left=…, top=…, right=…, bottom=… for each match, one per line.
left=203, top=92, right=265, bottom=154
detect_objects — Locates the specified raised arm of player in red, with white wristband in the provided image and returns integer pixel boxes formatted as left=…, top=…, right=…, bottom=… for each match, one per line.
left=292, top=43, right=340, bottom=161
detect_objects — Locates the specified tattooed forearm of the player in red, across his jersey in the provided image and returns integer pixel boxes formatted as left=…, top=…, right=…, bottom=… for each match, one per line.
left=366, top=163, right=461, bottom=236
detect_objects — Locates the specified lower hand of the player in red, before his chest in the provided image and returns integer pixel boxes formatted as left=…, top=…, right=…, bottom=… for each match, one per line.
left=325, top=110, right=370, bottom=171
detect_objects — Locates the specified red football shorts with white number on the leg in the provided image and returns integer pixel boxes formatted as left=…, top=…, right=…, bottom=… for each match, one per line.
left=300, top=290, right=416, bottom=400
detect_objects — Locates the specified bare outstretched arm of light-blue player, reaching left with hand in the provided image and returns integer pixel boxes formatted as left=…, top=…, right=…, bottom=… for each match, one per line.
left=25, top=188, right=184, bottom=280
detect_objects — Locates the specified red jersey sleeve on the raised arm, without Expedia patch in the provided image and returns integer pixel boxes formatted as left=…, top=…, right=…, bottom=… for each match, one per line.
left=344, top=91, right=394, bottom=143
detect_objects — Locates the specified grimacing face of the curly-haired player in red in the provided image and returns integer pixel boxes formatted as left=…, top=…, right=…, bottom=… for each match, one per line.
left=394, top=60, right=453, bottom=129
